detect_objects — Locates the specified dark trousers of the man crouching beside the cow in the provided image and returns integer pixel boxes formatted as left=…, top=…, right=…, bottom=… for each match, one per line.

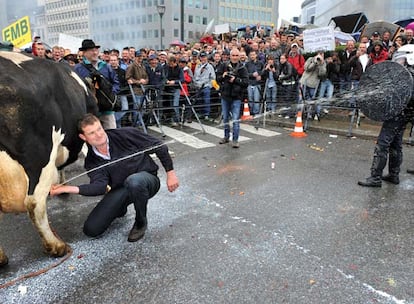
left=83, top=171, right=160, bottom=237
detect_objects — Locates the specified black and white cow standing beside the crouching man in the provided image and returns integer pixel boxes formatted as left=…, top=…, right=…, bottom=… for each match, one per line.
left=0, top=51, right=97, bottom=266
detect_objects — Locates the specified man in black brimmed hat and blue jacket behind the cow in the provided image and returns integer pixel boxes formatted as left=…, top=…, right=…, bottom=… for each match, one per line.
left=74, top=39, right=119, bottom=129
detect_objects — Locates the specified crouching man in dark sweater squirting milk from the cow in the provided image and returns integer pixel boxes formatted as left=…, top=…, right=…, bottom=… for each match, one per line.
left=50, top=114, right=179, bottom=242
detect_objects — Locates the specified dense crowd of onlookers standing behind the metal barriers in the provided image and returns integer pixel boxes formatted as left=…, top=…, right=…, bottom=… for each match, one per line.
left=32, top=25, right=414, bottom=128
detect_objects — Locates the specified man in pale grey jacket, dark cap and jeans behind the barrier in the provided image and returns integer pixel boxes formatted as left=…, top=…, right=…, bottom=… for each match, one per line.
left=193, top=51, right=216, bottom=120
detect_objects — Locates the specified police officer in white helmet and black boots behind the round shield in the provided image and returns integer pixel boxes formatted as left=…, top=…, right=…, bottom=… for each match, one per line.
left=358, top=45, right=414, bottom=187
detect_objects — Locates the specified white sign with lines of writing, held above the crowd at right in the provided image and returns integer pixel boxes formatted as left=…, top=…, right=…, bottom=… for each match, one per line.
left=303, top=26, right=335, bottom=52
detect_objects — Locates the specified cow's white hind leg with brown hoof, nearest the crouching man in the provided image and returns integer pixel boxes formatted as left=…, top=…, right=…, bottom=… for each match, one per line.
left=26, top=127, right=67, bottom=256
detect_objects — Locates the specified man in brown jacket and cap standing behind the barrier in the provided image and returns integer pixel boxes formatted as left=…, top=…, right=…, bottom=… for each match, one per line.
left=125, top=51, right=148, bottom=126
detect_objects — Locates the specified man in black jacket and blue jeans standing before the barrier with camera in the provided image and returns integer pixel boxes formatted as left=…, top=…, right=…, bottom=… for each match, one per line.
left=217, top=48, right=249, bottom=148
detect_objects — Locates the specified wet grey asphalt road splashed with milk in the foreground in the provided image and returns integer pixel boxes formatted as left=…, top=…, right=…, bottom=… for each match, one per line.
left=0, top=124, right=414, bottom=303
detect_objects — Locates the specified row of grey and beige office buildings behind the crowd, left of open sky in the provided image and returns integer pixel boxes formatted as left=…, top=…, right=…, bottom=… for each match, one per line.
left=0, top=0, right=279, bottom=49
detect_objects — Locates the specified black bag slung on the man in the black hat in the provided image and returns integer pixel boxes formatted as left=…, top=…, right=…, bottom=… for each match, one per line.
left=84, top=64, right=117, bottom=112
